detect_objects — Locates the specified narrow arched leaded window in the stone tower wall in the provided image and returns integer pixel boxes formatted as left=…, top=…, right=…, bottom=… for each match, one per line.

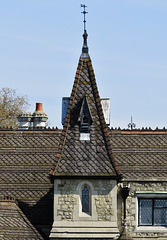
left=82, top=185, right=90, bottom=214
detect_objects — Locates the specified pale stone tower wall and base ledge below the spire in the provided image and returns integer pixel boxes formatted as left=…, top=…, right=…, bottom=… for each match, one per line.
left=50, top=179, right=118, bottom=239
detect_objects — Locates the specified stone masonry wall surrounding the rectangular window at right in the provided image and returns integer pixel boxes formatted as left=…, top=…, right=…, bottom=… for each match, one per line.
left=119, top=181, right=167, bottom=240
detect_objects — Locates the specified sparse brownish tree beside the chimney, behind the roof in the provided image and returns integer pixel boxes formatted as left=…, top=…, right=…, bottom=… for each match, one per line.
left=0, top=88, right=29, bottom=128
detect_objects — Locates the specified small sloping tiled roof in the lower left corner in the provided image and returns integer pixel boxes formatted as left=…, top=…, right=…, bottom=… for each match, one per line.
left=0, top=198, right=43, bottom=240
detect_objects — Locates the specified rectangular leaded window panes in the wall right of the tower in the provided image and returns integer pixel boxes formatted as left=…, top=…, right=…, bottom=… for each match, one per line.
left=139, top=198, right=167, bottom=226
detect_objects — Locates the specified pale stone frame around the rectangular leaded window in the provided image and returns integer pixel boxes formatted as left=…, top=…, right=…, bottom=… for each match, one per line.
left=136, top=191, right=167, bottom=233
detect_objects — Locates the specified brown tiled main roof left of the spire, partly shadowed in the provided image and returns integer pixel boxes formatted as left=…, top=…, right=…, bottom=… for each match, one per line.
left=0, top=130, right=60, bottom=231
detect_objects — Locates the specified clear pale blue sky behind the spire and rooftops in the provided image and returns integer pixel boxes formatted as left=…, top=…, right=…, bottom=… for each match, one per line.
left=0, top=0, right=167, bottom=129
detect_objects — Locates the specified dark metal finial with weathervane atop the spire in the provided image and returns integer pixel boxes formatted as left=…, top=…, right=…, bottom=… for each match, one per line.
left=81, top=4, right=89, bottom=58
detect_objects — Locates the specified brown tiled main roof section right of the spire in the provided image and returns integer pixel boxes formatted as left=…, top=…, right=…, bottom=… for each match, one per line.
left=110, top=130, right=167, bottom=180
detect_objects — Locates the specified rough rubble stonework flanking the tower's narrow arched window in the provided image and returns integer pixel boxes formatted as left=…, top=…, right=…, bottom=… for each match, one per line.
left=55, top=180, right=116, bottom=221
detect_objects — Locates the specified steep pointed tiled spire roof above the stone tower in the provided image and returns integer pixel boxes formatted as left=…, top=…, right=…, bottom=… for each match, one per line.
left=50, top=30, right=120, bottom=177
